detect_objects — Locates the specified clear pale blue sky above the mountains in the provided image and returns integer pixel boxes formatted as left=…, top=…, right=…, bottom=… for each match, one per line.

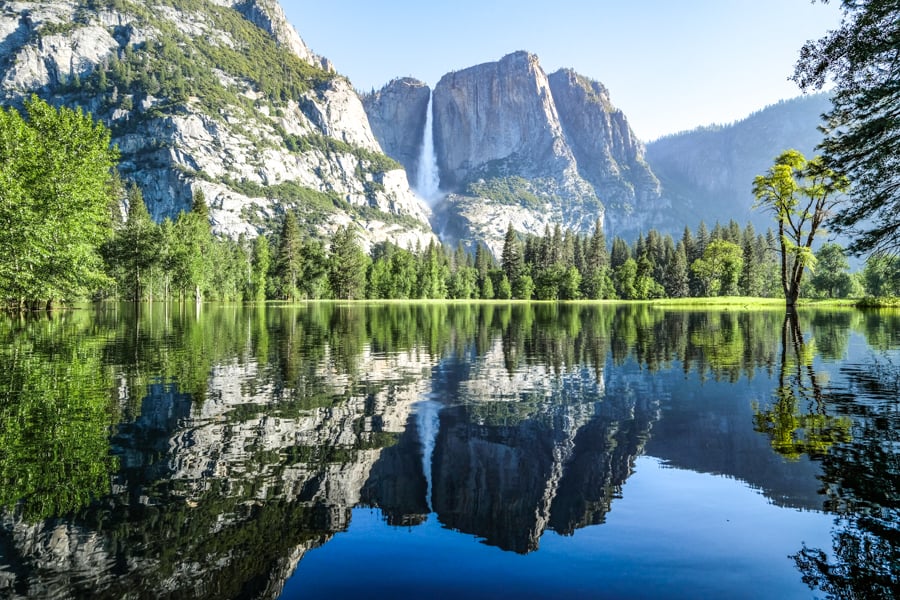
left=281, top=0, right=840, bottom=141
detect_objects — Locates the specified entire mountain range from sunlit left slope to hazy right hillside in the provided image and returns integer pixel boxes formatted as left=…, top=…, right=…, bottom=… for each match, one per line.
left=0, top=0, right=826, bottom=255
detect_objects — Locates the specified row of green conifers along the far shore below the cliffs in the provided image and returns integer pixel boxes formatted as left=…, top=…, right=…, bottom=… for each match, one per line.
left=104, top=195, right=781, bottom=301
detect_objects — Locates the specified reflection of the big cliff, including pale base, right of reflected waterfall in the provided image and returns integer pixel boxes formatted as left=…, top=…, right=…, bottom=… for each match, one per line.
left=434, top=340, right=657, bottom=552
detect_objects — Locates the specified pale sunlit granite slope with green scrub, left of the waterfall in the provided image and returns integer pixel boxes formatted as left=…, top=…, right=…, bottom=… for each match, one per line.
left=0, top=0, right=434, bottom=246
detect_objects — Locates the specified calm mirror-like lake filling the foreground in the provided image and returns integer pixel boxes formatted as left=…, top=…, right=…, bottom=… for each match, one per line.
left=0, top=303, right=900, bottom=599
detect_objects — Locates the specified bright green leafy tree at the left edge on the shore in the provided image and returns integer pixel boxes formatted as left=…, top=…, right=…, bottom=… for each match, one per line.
left=0, top=97, right=118, bottom=306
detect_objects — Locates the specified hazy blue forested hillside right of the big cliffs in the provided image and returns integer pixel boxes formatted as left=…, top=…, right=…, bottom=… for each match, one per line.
left=646, top=94, right=830, bottom=231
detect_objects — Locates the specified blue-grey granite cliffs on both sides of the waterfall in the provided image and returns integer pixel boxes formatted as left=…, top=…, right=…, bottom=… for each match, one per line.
left=366, top=52, right=661, bottom=254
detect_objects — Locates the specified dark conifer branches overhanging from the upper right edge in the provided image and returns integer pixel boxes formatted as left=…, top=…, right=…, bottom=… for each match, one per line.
left=793, top=0, right=900, bottom=254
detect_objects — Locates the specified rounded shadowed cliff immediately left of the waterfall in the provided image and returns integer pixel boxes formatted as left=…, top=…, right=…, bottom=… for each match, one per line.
left=362, top=77, right=431, bottom=181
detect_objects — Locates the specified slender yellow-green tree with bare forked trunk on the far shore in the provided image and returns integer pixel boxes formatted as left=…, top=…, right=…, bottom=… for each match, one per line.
left=753, top=150, right=849, bottom=309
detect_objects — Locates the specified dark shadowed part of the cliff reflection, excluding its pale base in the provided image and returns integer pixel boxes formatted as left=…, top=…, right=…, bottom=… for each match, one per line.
left=434, top=398, right=655, bottom=553
